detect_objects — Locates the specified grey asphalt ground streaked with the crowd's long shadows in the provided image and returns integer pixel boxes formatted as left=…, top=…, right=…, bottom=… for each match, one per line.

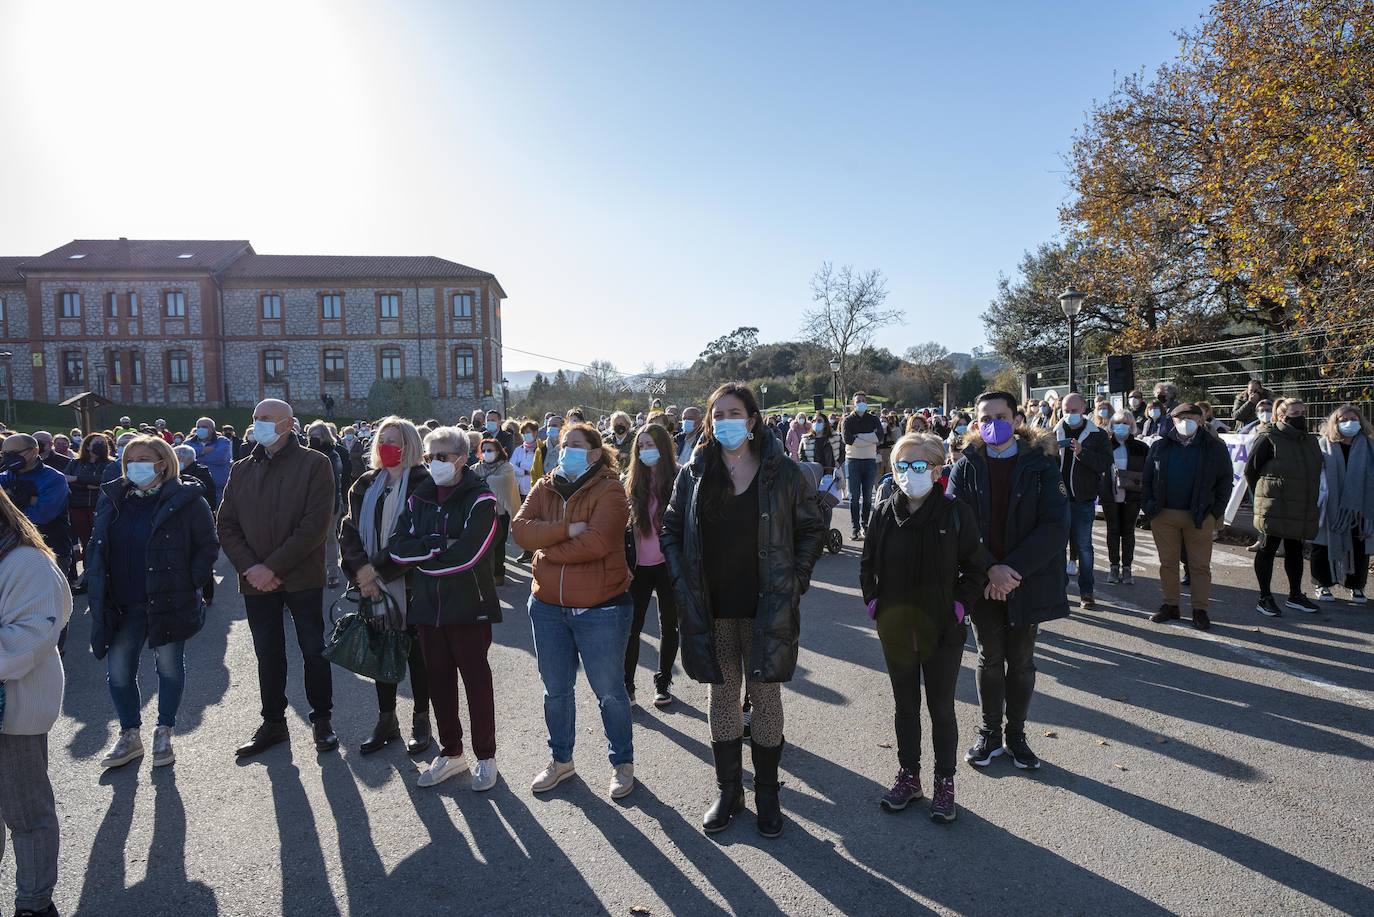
left=0, top=509, right=1374, bottom=917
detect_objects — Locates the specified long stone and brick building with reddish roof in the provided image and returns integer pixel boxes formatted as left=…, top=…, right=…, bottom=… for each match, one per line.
left=0, top=239, right=506, bottom=421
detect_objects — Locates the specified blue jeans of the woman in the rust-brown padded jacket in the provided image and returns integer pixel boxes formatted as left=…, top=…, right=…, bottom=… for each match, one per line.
left=529, top=595, right=635, bottom=767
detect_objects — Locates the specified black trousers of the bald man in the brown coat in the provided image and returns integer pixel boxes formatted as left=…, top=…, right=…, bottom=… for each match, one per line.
left=243, top=588, right=334, bottom=723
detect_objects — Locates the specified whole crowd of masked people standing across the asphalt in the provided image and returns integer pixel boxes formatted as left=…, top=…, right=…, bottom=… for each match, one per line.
left=0, top=384, right=1374, bottom=914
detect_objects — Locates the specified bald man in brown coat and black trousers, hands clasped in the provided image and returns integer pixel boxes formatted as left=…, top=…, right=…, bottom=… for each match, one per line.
left=218, top=399, right=339, bottom=758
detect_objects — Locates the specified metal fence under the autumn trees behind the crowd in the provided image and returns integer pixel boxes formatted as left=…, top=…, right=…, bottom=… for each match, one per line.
left=1026, top=318, right=1374, bottom=418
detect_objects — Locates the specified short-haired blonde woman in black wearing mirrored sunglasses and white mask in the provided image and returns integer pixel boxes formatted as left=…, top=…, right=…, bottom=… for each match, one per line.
left=859, top=433, right=992, bottom=822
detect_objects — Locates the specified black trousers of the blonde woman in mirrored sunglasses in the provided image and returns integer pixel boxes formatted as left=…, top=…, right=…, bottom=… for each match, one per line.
left=883, top=627, right=961, bottom=777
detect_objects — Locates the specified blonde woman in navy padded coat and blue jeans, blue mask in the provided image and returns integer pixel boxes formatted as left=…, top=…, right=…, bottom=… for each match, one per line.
left=87, top=436, right=220, bottom=767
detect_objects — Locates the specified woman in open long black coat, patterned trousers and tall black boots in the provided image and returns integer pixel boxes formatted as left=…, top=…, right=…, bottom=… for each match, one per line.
left=660, top=382, right=826, bottom=837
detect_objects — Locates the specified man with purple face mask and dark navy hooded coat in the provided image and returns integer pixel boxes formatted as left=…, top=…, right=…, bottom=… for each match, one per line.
left=949, top=392, right=1069, bottom=770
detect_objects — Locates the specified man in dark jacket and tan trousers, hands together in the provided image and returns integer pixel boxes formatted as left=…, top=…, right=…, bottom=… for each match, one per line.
left=1140, top=403, right=1234, bottom=631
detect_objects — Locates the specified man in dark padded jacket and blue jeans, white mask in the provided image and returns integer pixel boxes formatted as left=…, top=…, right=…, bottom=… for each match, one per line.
left=1054, top=392, right=1113, bottom=609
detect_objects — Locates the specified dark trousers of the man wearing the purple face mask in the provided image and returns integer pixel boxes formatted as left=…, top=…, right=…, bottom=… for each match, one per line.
left=973, top=599, right=1040, bottom=736
